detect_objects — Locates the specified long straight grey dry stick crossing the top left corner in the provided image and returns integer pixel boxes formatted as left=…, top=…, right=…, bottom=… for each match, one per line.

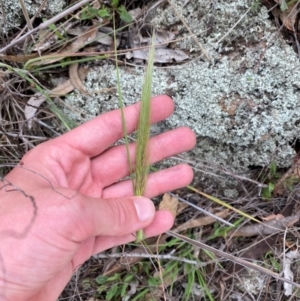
left=0, top=0, right=93, bottom=53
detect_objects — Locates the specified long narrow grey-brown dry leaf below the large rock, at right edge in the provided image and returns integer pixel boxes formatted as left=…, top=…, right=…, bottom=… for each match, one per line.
left=228, top=215, right=300, bottom=237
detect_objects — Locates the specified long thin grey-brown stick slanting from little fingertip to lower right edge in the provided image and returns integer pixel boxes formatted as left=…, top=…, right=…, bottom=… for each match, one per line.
left=166, top=231, right=300, bottom=288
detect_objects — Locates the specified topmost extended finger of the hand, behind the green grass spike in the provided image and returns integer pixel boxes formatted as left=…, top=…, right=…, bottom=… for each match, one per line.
left=56, top=95, right=174, bottom=157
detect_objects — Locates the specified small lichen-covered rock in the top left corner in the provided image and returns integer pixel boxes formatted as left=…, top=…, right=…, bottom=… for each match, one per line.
left=0, top=0, right=66, bottom=32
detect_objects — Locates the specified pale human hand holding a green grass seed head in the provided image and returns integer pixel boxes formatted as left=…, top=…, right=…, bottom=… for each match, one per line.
left=0, top=96, right=195, bottom=301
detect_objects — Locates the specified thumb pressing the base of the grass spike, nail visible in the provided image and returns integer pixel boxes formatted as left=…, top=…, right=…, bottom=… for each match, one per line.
left=55, top=194, right=155, bottom=242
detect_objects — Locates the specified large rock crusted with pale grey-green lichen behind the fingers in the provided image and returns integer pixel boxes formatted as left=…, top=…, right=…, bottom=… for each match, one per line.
left=67, top=0, right=300, bottom=170
